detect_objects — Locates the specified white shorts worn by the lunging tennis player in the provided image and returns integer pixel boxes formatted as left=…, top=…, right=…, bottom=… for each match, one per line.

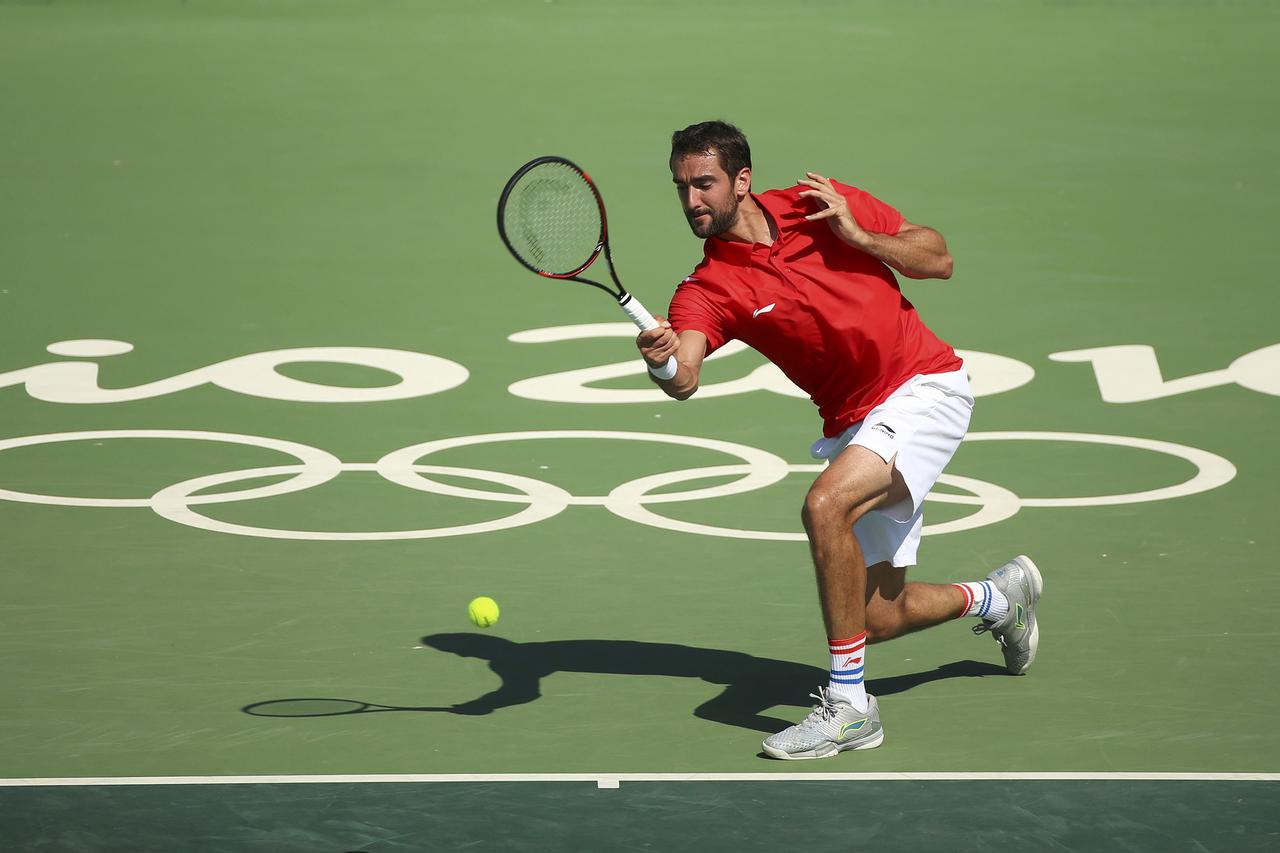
left=810, top=368, right=973, bottom=566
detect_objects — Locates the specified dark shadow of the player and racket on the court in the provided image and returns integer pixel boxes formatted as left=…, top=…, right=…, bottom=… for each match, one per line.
left=242, top=633, right=1005, bottom=734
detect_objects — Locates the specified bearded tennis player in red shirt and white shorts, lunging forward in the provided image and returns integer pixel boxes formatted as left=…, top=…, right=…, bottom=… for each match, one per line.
left=636, top=122, right=1043, bottom=758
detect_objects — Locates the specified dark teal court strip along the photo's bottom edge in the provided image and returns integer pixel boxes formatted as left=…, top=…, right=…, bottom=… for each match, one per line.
left=0, top=771, right=1280, bottom=853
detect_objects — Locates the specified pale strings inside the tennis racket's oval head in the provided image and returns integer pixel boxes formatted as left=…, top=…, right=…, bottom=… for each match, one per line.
left=504, top=163, right=603, bottom=275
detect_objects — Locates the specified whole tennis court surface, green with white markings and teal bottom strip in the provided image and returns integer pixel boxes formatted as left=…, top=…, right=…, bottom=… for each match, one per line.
left=0, top=0, right=1280, bottom=853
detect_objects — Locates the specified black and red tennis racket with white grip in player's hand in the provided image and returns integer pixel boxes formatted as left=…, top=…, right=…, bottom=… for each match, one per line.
left=498, top=156, right=676, bottom=379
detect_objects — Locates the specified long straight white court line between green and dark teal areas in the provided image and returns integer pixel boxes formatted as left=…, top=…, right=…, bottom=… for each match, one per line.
left=0, top=772, right=1280, bottom=788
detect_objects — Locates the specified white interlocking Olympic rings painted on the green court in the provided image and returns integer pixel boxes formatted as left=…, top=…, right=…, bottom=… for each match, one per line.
left=0, top=429, right=1235, bottom=542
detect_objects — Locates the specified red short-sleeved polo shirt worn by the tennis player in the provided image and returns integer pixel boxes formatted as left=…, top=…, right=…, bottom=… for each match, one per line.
left=668, top=181, right=963, bottom=437
